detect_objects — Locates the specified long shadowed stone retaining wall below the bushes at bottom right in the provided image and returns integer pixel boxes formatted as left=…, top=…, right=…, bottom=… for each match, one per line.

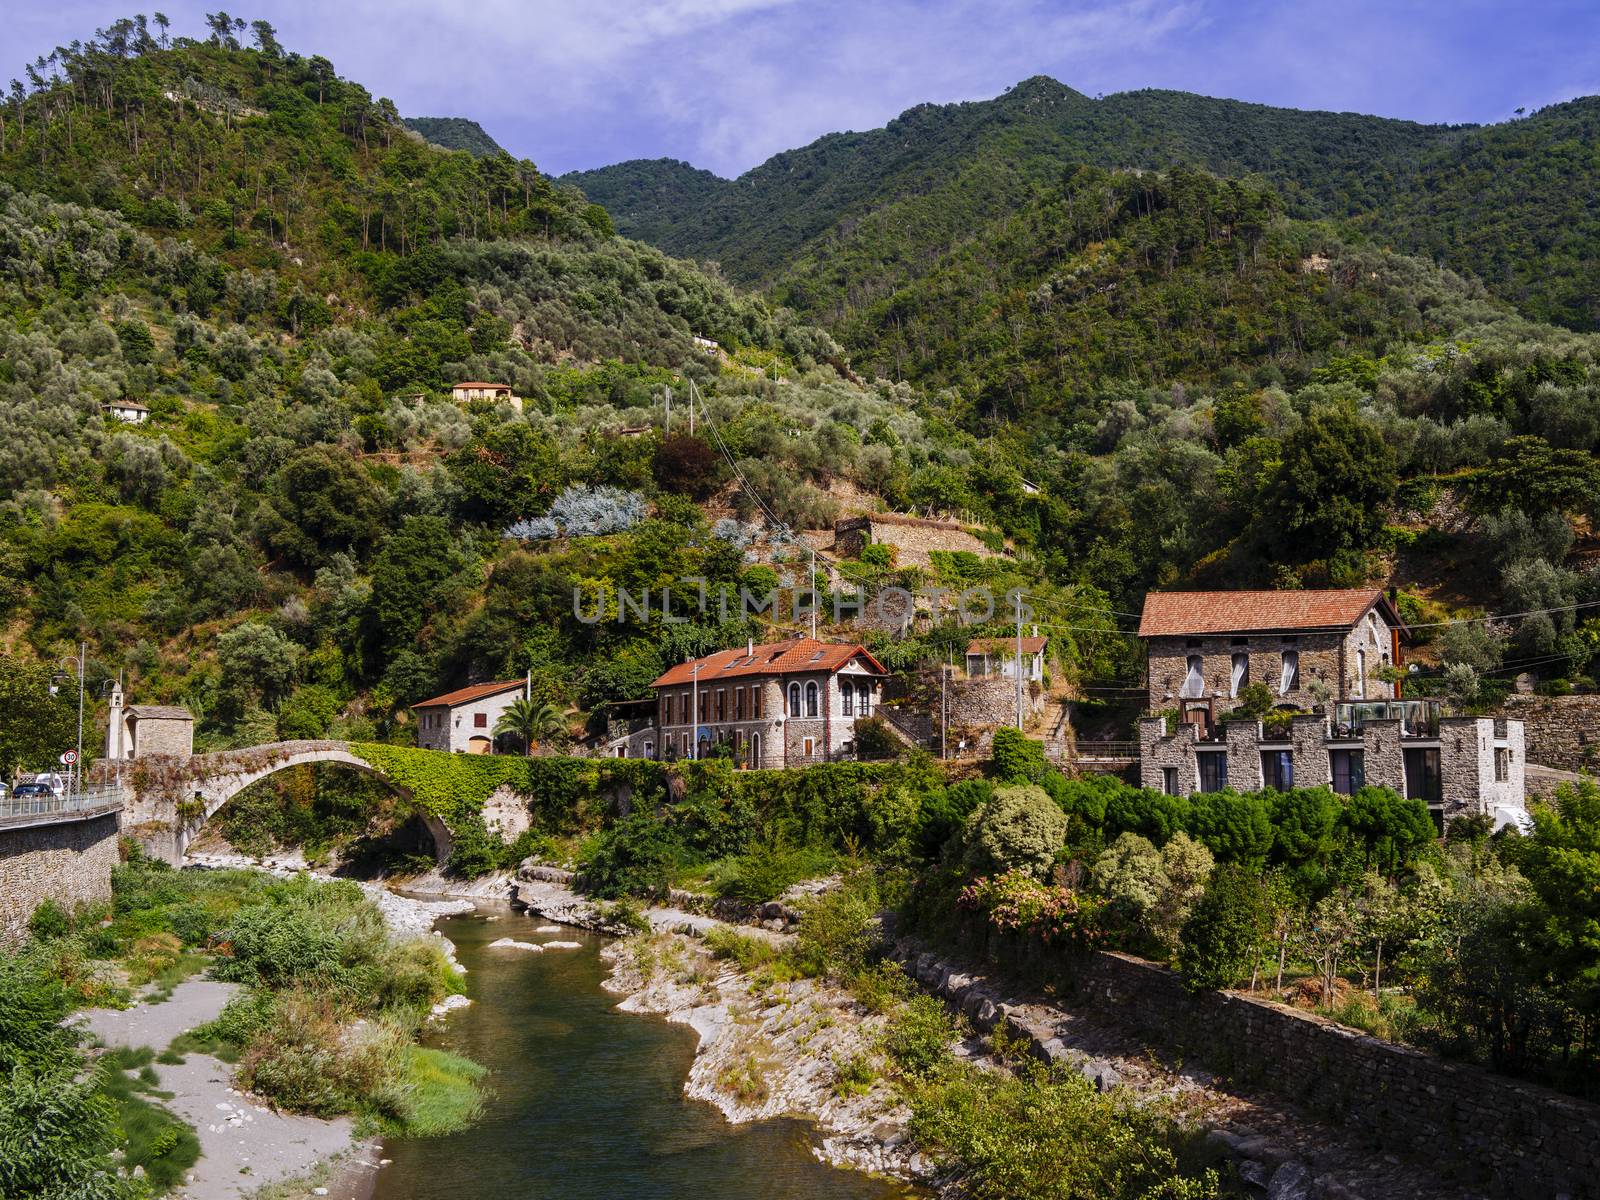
left=944, top=931, right=1600, bottom=1200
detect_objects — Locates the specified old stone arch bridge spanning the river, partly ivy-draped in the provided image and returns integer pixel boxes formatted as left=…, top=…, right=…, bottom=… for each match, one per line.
left=108, top=741, right=453, bottom=866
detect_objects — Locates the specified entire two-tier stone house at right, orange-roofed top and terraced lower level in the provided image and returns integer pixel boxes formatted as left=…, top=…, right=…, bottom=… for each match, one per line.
left=1139, top=589, right=1525, bottom=826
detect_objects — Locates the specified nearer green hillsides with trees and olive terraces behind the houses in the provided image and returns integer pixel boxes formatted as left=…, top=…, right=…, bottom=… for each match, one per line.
left=9, top=18, right=1600, bottom=764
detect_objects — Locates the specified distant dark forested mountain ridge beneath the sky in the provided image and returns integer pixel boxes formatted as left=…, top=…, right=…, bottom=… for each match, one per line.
left=565, top=77, right=1600, bottom=328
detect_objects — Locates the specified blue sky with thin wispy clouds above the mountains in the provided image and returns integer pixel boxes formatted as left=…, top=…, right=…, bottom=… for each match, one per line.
left=0, top=0, right=1600, bottom=176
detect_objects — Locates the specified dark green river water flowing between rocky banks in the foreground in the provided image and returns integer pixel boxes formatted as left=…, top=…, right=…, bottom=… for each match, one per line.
left=373, top=909, right=907, bottom=1200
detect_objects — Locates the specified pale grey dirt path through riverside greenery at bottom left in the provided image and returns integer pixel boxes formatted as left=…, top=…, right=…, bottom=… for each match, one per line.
left=82, top=979, right=354, bottom=1200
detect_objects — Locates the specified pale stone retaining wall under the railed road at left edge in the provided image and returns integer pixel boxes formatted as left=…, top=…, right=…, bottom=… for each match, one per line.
left=0, top=813, right=117, bottom=946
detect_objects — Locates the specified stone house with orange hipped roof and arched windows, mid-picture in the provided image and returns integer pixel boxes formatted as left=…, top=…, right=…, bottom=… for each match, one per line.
left=656, top=637, right=888, bottom=768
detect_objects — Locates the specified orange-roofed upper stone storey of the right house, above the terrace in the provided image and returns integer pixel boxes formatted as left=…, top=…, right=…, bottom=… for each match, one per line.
left=1139, top=589, right=1403, bottom=723
